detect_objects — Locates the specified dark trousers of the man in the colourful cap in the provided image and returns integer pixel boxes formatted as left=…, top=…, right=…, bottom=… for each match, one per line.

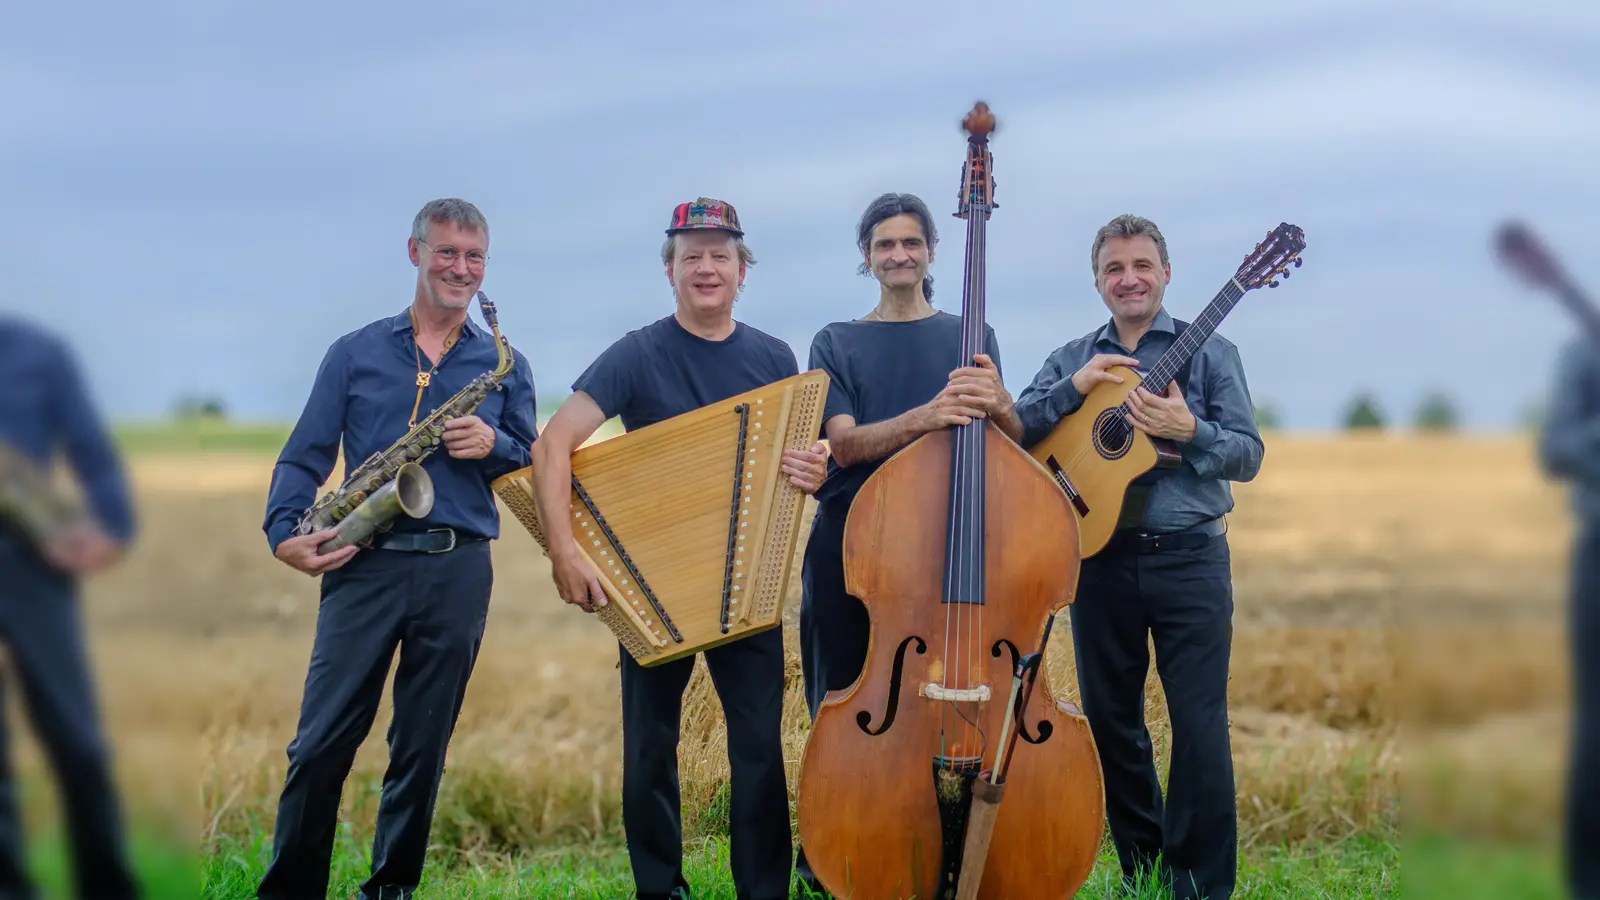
left=618, top=628, right=792, bottom=900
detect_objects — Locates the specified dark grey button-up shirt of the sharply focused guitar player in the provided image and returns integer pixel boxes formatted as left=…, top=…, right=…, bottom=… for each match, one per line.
left=1016, top=309, right=1266, bottom=532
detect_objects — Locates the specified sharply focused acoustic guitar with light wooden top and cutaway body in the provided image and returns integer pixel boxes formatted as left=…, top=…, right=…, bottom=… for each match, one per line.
left=1027, top=223, right=1306, bottom=559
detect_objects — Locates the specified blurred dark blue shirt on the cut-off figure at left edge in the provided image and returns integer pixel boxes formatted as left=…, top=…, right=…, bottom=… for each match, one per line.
left=0, top=315, right=134, bottom=543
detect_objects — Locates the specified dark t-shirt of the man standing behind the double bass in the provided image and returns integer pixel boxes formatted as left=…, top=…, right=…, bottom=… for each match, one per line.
left=810, top=312, right=1003, bottom=519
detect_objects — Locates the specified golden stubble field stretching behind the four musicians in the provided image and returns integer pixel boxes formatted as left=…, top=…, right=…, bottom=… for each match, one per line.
left=21, top=434, right=1571, bottom=897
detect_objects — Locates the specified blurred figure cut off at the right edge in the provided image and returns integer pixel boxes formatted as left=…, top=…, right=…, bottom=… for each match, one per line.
left=1539, top=335, right=1600, bottom=900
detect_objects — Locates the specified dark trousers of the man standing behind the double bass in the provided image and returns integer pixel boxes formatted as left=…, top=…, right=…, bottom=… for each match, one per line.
left=795, top=516, right=872, bottom=892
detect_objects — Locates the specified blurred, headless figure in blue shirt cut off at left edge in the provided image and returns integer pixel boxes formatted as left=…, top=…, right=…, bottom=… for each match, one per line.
left=0, top=315, right=139, bottom=900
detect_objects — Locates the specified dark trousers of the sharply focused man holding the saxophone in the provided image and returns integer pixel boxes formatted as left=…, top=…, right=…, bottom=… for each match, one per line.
left=256, top=541, right=494, bottom=900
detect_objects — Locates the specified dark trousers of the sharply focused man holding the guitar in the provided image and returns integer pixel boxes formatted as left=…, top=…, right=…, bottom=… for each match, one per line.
left=1067, top=525, right=1238, bottom=900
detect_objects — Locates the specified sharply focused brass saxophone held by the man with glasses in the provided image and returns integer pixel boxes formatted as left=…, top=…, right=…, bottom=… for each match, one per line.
left=294, top=291, right=517, bottom=552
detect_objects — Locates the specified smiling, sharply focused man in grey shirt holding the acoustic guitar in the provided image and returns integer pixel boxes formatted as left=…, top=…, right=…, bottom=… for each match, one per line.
left=1002, top=215, right=1264, bottom=900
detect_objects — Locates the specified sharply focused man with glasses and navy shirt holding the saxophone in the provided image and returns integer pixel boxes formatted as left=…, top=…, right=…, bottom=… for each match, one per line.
left=258, top=199, right=536, bottom=900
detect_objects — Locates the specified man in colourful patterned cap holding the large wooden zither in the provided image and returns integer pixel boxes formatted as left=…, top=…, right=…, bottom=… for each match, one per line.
left=533, top=197, right=827, bottom=900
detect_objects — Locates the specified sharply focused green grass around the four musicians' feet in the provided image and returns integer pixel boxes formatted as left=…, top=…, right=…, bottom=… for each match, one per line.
left=203, top=826, right=1401, bottom=900
